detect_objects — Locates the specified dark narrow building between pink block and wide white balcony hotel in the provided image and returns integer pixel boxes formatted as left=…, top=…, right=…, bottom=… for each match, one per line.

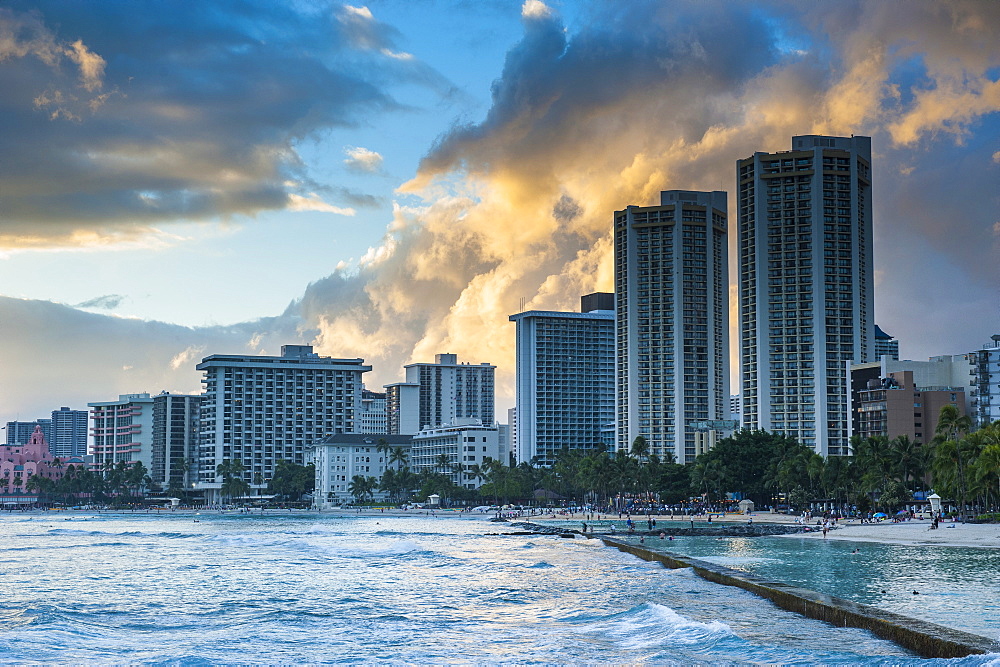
left=150, top=392, right=201, bottom=491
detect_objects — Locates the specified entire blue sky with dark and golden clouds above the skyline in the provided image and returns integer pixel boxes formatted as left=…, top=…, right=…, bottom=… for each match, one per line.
left=0, top=0, right=1000, bottom=422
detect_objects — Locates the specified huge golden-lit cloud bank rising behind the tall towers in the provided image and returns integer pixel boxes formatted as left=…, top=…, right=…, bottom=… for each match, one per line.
left=297, top=2, right=1000, bottom=393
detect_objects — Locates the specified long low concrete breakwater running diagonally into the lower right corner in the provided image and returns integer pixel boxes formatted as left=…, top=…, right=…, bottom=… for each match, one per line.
left=601, top=540, right=1000, bottom=658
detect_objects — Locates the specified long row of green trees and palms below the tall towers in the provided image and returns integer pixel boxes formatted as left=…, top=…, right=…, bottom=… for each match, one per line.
left=349, top=405, right=1000, bottom=514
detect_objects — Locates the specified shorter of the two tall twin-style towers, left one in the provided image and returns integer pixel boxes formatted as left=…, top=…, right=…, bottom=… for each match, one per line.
left=614, top=190, right=729, bottom=463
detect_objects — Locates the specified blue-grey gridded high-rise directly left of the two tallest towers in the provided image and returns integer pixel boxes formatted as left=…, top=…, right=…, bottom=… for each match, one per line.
left=510, top=293, right=615, bottom=465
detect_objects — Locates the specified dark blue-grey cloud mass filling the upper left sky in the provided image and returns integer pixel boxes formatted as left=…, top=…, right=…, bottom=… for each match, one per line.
left=0, top=0, right=441, bottom=241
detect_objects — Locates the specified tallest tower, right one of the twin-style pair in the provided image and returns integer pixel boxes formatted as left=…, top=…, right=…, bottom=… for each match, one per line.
left=736, top=135, right=875, bottom=456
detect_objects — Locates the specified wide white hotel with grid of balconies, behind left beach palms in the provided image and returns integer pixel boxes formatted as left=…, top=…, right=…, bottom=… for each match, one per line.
left=196, top=345, right=371, bottom=500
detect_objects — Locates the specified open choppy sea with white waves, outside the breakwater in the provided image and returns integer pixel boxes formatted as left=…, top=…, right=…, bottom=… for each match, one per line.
left=0, top=514, right=1000, bottom=665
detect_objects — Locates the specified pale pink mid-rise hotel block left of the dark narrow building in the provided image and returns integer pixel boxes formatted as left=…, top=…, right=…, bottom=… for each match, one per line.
left=87, top=393, right=153, bottom=471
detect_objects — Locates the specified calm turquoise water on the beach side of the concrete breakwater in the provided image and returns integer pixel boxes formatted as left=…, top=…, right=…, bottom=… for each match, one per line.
left=608, top=536, right=1000, bottom=640
